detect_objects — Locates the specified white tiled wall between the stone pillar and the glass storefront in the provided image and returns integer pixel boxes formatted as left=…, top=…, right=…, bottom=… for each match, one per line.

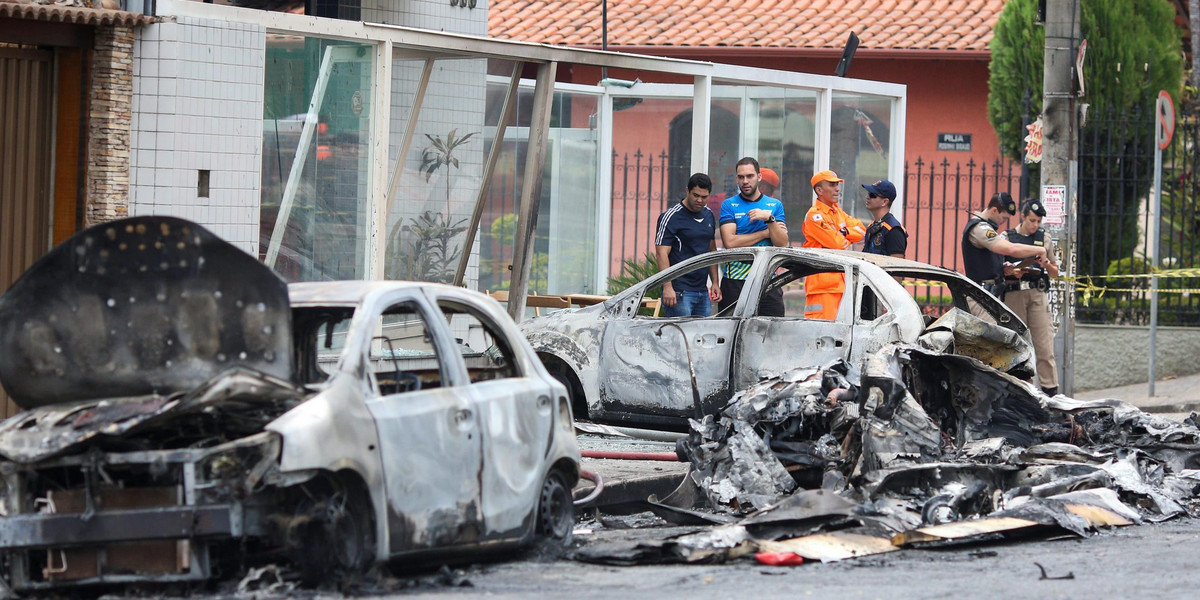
left=130, top=17, right=265, bottom=256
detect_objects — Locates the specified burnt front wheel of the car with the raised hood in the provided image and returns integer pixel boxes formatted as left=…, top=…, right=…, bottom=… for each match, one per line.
left=287, top=480, right=376, bottom=587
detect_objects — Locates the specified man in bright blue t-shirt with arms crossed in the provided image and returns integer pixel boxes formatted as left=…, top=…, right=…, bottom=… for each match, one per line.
left=719, top=156, right=788, bottom=317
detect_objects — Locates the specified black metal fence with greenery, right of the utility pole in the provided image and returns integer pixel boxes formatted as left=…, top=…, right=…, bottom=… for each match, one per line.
left=1075, top=106, right=1200, bottom=325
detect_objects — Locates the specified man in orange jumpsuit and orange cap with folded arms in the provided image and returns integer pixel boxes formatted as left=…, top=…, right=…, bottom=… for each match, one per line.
left=800, top=170, right=866, bottom=320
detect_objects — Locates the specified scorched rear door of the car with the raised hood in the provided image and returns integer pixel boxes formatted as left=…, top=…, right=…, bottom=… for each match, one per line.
left=437, top=298, right=554, bottom=539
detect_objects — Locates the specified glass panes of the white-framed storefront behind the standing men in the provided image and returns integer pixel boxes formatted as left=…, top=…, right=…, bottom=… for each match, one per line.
left=259, top=27, right=898, bottom=294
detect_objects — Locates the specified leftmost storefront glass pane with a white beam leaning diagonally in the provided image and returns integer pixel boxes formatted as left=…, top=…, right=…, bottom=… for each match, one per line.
left=259, top=35, right=374, bottom=281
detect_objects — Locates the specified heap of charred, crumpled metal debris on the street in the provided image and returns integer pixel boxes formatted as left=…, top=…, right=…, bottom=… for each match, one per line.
left=576, top=344, right=1200, bottom=564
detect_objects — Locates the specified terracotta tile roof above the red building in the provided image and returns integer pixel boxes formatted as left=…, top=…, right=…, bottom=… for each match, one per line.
left=487, top=0, right=1004, bottom=52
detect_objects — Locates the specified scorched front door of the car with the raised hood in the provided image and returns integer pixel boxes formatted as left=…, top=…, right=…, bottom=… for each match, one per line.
left=364, top=294, right=484, bottom=554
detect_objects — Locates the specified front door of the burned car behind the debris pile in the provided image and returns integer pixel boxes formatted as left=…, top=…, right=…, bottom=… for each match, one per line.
left=599, top=253, right=754, bottom=425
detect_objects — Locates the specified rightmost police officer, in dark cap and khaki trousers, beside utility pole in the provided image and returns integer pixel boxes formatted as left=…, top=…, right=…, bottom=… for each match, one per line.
left=1004, top=200, right=1058, bottom=396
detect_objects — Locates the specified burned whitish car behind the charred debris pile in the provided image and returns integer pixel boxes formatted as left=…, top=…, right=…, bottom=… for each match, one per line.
left=521, top=247, right=1034, bottom=428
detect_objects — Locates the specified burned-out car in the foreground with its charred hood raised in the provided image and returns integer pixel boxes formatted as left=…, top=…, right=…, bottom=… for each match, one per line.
left=0, top=217, right=580, bottom=592
